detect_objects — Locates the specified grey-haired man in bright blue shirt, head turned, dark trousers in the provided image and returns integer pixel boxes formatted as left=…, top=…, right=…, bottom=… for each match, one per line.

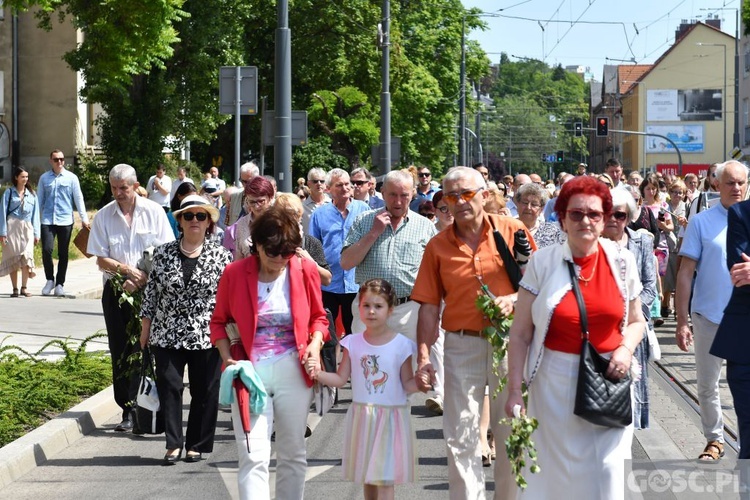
left=307, top=168, right=370, bottom=335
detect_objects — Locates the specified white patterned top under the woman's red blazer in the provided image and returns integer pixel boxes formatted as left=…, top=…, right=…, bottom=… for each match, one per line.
left=251, top=269, right=296, bottom=363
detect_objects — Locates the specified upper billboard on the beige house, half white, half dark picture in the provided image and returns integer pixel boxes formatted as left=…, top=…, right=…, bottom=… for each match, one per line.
left=646, top=89, right=723, bottom=122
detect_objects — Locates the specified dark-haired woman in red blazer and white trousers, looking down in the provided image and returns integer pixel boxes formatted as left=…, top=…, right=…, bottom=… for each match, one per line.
left=211, top=207, right=328, bottom=500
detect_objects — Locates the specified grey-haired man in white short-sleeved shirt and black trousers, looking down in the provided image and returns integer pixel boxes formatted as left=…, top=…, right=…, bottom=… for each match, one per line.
left=88, top=163, right=174, bottom=432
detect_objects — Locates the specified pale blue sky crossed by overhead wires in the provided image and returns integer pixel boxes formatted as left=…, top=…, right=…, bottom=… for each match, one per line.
left=463, top=0, right=741, bottom=80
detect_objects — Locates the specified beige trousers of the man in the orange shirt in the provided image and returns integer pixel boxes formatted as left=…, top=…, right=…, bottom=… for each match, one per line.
left=443, top=332, right=517, bottom=500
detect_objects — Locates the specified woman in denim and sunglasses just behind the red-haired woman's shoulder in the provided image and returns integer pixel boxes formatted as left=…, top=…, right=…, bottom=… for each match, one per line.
left=602, top=189, right=657, bottom=429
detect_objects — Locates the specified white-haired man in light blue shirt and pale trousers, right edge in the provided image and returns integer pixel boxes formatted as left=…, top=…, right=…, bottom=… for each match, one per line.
left=675, top=161, right=747, bottom=461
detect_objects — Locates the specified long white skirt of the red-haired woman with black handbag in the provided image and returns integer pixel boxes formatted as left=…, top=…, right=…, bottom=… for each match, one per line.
left=520, top=348, right=633, bottom=500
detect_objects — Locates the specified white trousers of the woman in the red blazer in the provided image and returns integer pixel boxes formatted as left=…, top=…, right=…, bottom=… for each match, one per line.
left=232, top=351, right=312, bottom=500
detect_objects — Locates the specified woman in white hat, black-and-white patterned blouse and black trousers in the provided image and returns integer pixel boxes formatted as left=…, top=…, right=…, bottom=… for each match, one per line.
left=141, top=195, right=232, bottom=465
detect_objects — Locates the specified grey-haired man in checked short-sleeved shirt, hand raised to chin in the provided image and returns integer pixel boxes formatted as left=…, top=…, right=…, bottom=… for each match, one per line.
left=341, top=170, right=437, bottom=342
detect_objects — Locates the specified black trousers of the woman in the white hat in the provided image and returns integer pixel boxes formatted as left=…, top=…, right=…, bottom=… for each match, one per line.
left=151, top=346, right=221, bottom=453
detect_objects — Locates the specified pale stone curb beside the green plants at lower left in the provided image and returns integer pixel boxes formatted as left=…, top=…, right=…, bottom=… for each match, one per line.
left=0, top=386, right=122, bottom=488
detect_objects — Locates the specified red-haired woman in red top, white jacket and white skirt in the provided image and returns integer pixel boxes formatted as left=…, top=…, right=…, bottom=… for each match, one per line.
left=505, top=177, right=645, bottom=499
